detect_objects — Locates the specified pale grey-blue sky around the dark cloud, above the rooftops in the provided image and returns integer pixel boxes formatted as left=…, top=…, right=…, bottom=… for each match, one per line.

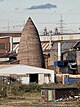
left=0, top=0, right=80, bottom=32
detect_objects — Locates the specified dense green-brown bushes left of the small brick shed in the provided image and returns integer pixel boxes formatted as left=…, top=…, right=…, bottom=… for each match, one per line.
left=0, top=82, right=42, bottom=97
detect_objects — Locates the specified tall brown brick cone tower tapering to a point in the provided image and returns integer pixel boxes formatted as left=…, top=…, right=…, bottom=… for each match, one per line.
left=17, top=18, right=44, bottom=68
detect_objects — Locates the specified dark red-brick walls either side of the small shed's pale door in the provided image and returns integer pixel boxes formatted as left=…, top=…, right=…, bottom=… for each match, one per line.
left=42, top=88, right=80, bottom=102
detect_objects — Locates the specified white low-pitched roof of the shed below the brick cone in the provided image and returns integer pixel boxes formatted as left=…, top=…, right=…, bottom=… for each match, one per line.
left=0, top=65, right=54, bottom=75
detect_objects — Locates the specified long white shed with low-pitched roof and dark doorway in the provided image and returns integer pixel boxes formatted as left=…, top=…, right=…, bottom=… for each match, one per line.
left=0, top=65, right=55, bottom=84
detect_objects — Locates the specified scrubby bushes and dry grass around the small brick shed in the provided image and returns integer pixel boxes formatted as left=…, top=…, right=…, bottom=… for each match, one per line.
left=0, top=82, right=80, bottom=105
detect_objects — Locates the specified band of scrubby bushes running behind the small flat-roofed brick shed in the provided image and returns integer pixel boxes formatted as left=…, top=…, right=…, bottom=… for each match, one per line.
left=0, top=82, right=80, bottom=97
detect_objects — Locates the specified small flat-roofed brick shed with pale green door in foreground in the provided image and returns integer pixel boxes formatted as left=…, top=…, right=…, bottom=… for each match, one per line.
left=41, top=86, right=80, bottom=102
